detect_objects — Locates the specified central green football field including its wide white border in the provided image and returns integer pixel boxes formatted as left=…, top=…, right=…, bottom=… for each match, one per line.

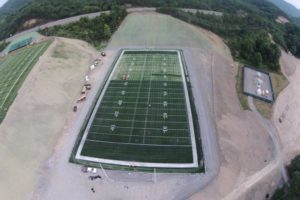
left=75, top=50, right=199, bottom=168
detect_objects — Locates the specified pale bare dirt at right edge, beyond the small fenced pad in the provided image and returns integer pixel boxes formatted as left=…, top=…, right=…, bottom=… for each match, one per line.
left=273, top=51, right=300, bottom=163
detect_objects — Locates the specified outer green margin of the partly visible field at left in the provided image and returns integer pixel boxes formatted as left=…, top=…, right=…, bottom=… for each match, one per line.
left=0, top=39, right=53, bottom=124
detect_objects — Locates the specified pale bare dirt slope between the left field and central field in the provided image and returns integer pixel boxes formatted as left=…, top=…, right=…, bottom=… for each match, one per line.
left=0, top=38, right=95, bottom=200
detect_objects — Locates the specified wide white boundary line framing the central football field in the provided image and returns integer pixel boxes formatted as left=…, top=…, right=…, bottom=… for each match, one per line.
left=75, top=49, right=198, bottom=168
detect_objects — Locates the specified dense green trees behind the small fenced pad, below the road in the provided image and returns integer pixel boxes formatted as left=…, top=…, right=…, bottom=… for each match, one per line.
left=159, top=8, right=280, bottom=71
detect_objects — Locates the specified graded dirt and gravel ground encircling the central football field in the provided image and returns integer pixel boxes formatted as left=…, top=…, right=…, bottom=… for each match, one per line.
left=25, top=12, right=280, bottom=200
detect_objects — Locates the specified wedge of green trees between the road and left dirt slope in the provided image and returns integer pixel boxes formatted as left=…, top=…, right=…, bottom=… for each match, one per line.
left=40, top=6, right=127, bottom=47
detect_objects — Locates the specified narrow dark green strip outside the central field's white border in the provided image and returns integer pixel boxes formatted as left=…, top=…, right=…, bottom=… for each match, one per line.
left=69, top=49, right=204, bottom=173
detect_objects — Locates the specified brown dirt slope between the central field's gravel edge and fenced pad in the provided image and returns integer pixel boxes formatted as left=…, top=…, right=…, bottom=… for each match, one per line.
left=191, top=54, right=280, bottom=200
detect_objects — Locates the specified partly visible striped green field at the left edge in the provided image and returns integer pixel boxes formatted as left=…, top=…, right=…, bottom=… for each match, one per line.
left=0, top=41, right=51, bottom=123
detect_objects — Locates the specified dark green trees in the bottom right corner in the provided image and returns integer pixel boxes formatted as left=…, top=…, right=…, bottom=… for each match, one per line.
left=272, top=155, right=300, bottom=200
